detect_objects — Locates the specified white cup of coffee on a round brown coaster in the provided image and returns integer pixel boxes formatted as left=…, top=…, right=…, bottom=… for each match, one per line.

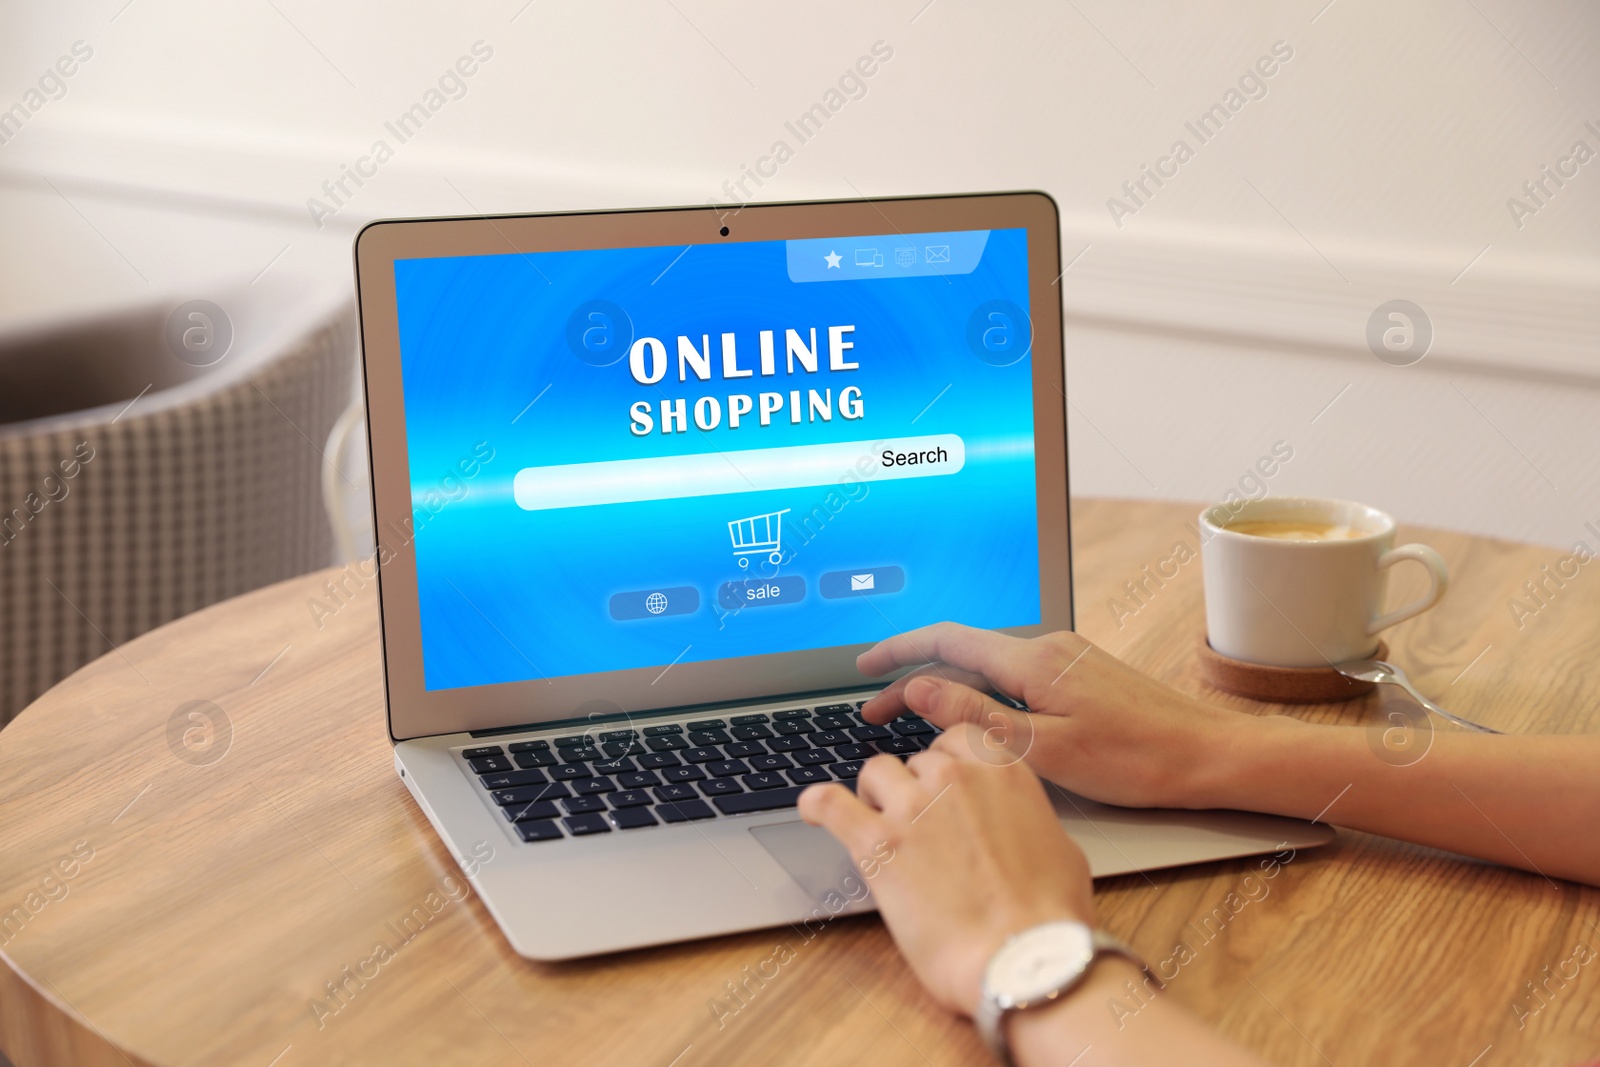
left=1200, top=496, right=1450, bottom=667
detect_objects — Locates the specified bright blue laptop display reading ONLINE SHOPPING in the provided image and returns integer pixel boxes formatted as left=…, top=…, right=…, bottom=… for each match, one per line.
left=395, top=229, right=1040, bottom=689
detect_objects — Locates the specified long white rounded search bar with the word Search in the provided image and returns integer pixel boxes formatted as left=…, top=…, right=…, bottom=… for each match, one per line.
left=512, top=434, right=966, bottom=512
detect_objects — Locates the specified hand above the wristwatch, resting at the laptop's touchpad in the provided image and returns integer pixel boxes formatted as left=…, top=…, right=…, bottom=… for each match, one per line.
left=800, top=723, right=1094, bottom=1014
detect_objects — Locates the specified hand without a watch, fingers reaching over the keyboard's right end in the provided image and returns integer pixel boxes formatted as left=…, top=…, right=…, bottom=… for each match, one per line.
left=858, top=622, right=1261, bottom=808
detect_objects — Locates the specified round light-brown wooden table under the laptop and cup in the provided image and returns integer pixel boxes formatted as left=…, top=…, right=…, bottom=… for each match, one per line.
left=0, top=501, right=1600, bottom=1067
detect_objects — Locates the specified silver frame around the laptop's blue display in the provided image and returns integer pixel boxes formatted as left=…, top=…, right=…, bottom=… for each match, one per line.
left=355, top=192, right=1072, bottom=741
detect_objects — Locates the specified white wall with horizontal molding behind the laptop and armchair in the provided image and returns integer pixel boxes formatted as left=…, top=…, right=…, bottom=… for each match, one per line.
left=0, top=0, right=1600, bottom=544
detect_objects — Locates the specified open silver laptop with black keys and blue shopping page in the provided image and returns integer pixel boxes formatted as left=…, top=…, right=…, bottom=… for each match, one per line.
left=355, top=192, right=1330, bottom=960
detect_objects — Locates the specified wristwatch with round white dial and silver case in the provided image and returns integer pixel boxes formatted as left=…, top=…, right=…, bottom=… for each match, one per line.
left=976, top=920, right=1162, bottom=1067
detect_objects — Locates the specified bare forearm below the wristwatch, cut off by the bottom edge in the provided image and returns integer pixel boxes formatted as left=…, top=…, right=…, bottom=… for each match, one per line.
left=1006, top=958, right=1262, bottom=1067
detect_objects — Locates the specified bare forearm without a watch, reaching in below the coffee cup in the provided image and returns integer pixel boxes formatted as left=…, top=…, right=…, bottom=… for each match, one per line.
left=1195, top=717, right=1600, bottom=885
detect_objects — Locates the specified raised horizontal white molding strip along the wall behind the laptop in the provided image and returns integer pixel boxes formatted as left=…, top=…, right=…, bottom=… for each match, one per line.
left=0, top=115, right=1600, bottom=387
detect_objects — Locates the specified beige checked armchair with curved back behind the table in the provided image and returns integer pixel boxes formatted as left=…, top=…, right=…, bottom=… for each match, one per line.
left=0, top=283, right=360, bottom=725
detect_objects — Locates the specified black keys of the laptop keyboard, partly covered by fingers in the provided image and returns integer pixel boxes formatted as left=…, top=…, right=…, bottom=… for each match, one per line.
left=459, top=704, right=939, bottom=841
